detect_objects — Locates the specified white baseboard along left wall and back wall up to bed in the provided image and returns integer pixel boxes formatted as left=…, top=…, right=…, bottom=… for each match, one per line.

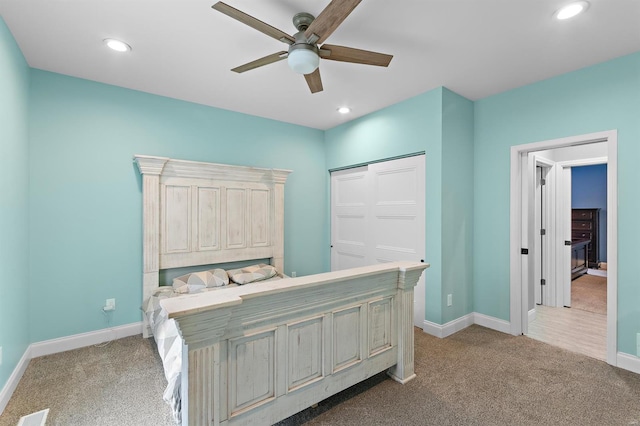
left=0, top=322, right=142, bottom=414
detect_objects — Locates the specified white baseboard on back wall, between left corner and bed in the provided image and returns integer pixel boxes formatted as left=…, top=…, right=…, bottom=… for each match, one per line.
left=31, top=322, right=142, bottom=358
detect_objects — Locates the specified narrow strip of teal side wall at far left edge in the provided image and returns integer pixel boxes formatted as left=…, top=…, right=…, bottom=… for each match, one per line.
left=0, top=17, right=30, bottom=389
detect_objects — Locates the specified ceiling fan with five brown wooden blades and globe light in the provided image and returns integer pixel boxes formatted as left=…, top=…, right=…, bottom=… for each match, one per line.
left=211, top=0, right=393, bottom=93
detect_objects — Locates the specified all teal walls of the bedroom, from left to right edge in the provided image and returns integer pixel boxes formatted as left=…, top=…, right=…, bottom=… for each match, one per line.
left=0, top=14, right=640, bottom=400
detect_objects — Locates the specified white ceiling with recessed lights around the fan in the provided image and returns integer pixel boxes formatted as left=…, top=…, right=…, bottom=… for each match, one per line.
left=0, top=0, right=640, bottom=129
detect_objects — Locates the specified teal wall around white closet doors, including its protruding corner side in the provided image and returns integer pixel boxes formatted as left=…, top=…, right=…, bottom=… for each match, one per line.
left=325, top=88, right=473, bottom=324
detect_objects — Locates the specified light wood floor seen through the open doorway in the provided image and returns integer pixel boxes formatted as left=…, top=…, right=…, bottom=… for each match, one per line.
left=527, top=305, right=607, bottom=361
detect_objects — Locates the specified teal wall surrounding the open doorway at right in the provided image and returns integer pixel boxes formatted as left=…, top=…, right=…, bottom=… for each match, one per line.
left=473, top=53, right=640, bottom=354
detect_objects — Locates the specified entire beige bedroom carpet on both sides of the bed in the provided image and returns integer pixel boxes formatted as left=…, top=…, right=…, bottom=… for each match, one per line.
left=0, top=325, right=640, bottom=426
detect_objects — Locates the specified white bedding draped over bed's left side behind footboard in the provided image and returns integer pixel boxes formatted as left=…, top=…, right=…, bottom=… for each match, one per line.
left=142, top=276, right=283, bottom=424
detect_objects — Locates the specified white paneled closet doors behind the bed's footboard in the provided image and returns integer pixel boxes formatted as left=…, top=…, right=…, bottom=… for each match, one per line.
left=331, top=155, right=425, bottom=328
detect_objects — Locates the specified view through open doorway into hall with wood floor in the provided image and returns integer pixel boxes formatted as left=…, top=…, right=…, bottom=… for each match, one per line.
left=527, top=158, right=607, bottom=360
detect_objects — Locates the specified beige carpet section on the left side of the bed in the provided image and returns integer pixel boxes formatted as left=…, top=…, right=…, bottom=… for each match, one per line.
left=0, top=336, right=173, bottom=426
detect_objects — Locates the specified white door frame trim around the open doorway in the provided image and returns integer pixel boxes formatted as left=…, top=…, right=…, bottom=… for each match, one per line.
left=509, top=130, right=618, bottom=366
